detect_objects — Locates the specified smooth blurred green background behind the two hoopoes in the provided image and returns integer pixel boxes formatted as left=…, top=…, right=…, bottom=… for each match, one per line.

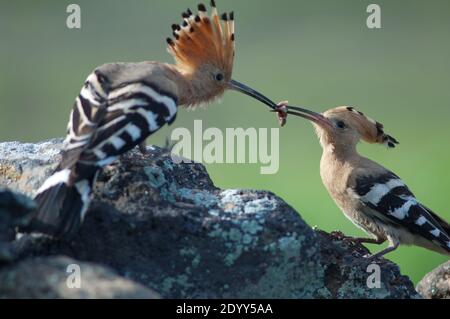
left=0, top=0, right=450, bottom=282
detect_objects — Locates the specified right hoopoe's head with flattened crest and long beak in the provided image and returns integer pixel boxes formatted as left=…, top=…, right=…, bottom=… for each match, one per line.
left=287, top=106, right=398, bottom=148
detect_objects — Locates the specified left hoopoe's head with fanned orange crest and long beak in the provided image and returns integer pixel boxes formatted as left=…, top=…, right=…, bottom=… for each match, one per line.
left=167, top=0, right=276, bottom=108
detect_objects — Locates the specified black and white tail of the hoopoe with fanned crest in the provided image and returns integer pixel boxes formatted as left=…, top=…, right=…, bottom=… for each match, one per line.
left=27, top=169, right=96, bottom=239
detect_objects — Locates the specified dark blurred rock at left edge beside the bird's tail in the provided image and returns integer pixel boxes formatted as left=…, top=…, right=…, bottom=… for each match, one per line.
left=0, top=187, right=35, bottom=263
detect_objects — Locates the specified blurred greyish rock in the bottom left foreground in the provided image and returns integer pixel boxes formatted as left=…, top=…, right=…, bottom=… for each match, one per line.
left=0, top=256, right=159, bottom=299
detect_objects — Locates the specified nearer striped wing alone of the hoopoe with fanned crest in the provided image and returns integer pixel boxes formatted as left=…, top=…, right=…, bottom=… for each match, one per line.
left=80, top=82, right=178, bottom=167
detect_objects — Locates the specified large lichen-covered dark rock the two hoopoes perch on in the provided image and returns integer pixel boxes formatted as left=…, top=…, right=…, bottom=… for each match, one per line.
left=0, top=141, right=419, bottom=298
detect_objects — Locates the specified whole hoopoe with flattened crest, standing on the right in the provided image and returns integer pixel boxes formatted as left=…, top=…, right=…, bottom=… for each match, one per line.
left=277, top=102, right=450, bottom=260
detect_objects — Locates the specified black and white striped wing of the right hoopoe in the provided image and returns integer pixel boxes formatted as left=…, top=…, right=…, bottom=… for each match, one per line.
left=352, top=172, right=450, bottom=251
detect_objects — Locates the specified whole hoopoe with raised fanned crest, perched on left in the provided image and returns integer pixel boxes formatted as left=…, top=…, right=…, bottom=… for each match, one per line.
left=30, top=1, right=276, bottom=238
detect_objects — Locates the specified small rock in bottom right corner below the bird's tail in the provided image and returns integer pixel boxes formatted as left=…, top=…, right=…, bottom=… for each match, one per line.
left=417, top=261, right=450, bottom=299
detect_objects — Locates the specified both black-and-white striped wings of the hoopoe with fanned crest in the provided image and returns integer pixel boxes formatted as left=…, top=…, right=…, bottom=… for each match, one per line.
left=61, top=71, right=178, bottom=168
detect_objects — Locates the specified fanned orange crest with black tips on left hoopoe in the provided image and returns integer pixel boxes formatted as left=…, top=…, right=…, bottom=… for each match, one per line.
left=167, top=0, right=235, bottom=77
